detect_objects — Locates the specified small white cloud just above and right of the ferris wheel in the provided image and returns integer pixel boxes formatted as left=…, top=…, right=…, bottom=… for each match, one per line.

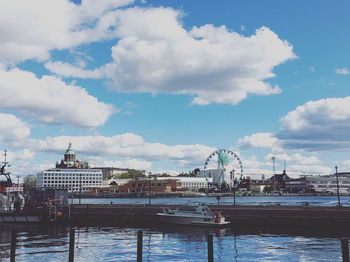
left=238, top=133, right=279, bottom=148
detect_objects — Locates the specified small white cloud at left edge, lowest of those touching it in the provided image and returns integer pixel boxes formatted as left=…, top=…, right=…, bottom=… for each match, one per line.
left=0, top=113, right=30, bottom=146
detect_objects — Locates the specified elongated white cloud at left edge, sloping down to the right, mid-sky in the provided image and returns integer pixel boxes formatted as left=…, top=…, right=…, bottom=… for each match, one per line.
left=0, top=69, right=113, bottom=127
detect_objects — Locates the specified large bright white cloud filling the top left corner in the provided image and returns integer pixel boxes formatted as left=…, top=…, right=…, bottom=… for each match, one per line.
left=0, top=0, right=133, bottom=64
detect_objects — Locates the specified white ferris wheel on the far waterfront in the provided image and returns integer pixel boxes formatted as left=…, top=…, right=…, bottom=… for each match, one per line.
left=204, top=149, right=243, bottom=188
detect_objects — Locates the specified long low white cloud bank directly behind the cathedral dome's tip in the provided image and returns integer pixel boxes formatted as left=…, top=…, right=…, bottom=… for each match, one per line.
left=31, top=133, right=215, bottom=166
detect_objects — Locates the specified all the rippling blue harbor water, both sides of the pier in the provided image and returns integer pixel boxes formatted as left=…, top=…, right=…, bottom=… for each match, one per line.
left=0, top=196, right=350, bottom=262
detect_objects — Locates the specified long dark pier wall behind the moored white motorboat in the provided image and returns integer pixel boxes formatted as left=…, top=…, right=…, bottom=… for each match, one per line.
left=69, top=204, right=350, bottom=231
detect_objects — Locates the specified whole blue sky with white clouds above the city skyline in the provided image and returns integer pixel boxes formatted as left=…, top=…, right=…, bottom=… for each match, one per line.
left=0, top=0, right=350, bottom=177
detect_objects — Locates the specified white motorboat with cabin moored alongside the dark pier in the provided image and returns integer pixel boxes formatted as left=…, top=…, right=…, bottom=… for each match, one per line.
left=157, top=204, right=230, bottom=227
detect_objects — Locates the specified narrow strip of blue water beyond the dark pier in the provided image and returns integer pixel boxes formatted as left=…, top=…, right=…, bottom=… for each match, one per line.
left=70, top=196, right=350, bottom=206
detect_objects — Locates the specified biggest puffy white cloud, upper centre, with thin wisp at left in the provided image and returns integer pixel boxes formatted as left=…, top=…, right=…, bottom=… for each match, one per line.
left=47, top=8, right=295, bottom=105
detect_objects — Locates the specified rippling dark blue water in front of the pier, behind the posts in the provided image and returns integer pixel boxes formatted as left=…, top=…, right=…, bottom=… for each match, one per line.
left=0, top=226, right=342, bottom=262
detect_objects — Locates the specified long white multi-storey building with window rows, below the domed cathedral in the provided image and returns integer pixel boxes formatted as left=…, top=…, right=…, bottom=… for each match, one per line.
left=36, top=168, right=102, bottom=192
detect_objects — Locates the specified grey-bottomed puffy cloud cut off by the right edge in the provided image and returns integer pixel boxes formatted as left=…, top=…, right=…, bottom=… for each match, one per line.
left=276, top=97, right=350, bottom=150
